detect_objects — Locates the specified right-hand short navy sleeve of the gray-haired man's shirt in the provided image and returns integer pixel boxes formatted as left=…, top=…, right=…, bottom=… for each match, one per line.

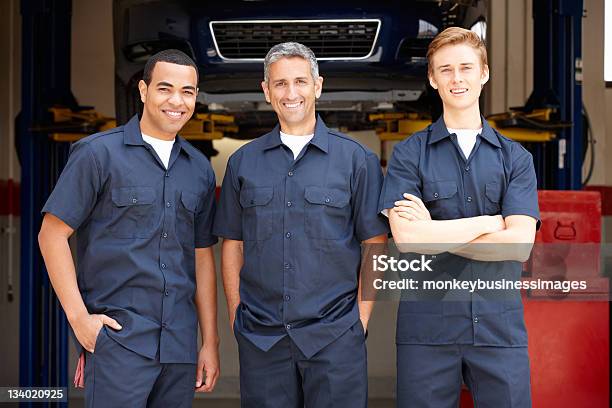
left=352, top=153, right=389, bottom=241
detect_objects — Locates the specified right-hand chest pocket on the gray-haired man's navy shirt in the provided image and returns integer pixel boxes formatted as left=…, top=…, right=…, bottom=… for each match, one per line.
left=304, top=186, right=352, bottom=239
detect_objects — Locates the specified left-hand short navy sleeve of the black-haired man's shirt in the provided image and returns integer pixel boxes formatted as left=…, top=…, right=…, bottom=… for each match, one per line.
left=41, top=142, right=102, bottom=230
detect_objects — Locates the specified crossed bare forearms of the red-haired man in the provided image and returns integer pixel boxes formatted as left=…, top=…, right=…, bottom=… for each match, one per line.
left=389, top=194, right=536, bottom=262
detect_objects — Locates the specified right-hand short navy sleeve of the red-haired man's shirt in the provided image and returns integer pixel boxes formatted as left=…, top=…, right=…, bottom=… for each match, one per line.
left=502, top=146, right=541, bottom=229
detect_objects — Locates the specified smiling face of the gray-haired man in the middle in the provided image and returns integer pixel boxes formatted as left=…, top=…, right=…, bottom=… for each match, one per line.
left=261, top=57, right=323, bottom=135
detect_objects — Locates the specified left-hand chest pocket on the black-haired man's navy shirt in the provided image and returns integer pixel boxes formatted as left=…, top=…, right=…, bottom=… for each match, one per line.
left=109, top=187, right=159, bottom=238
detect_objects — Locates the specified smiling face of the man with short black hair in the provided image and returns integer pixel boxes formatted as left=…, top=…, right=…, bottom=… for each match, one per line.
left=138, top=62, right=198, bottom=140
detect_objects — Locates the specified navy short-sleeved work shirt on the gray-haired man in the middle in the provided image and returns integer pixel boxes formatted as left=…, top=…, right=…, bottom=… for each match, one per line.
left=213, top=118, right=388, bottom=357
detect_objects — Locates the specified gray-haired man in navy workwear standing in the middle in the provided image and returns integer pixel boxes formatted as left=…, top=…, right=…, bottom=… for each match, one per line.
left=213, top=43, right=389, bottom=408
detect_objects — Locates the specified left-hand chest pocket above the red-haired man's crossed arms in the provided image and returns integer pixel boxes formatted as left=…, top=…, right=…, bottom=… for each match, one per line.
left=423, top=181, right=461, bottom=220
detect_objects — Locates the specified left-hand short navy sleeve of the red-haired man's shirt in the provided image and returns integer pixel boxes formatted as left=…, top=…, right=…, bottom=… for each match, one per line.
left=378, top=136, right=423, bottom=212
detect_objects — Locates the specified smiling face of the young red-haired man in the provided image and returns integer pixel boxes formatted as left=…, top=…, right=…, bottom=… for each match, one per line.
left=429, top=44, right=489, bottom=112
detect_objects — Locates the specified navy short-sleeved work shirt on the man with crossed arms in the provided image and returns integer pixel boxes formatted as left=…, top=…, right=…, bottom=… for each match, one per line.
left=379, top=117, right=540, bottom=347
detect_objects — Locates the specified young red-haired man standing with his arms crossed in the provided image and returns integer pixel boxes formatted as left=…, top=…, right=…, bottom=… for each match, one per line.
left=379, top=27, right=539, bottom=408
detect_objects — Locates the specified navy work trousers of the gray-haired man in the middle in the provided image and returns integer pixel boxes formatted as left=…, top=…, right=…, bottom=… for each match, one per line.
left=235, top=321, right=368, bottom=408
